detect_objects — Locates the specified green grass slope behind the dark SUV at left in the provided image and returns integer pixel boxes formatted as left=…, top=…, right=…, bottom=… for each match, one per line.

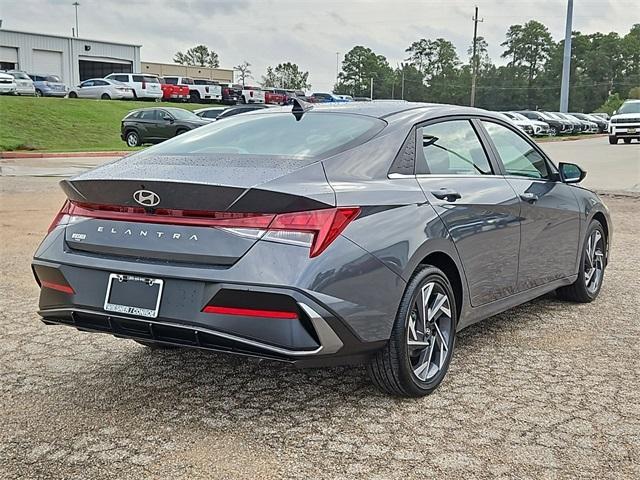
left=0, top=96, right=205, bottom=152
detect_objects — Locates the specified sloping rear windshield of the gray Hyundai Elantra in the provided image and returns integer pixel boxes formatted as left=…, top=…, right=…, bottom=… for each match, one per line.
left=147, top=112, right=386, bottom=157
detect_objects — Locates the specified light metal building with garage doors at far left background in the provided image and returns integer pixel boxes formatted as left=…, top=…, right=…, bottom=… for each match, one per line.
left=0, top=29, right=140, bottom=86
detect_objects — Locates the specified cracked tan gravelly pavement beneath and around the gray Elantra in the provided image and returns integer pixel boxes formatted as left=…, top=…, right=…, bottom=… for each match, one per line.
left=0, top=156, right=640, bottom=479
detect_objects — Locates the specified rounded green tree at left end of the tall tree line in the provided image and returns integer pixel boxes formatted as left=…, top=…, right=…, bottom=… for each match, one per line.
left=334, top=45, right=393, bottom=98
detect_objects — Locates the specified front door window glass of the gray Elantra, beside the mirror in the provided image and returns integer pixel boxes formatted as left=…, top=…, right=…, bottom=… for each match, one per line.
left=482, top=121, right=549, bottom=178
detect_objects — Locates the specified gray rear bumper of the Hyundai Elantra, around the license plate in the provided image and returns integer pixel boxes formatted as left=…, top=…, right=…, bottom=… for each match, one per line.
left=32, top=229, right=405, bottom=366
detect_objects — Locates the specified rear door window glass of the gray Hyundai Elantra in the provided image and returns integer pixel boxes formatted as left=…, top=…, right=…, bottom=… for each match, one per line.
left=418, top=120, right=493, bottom=175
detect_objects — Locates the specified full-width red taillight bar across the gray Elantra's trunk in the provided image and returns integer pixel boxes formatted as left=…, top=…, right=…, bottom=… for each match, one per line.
left=49, top=201, right=360, bottom=258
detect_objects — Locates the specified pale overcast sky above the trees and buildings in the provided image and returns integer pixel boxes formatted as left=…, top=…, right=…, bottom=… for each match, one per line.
left=0, top=0, right=640, bottom=91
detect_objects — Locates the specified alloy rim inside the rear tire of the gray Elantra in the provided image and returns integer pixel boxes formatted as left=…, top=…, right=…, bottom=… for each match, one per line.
left=407, top=282, right=453, bottom=382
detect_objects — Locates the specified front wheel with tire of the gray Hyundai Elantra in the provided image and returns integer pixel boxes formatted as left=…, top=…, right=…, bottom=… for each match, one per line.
left=556, top=220, right=607, bottom=303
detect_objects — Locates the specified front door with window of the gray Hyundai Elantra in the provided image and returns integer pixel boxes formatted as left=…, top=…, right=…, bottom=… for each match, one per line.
left=482, top=120, right=580, bottom=291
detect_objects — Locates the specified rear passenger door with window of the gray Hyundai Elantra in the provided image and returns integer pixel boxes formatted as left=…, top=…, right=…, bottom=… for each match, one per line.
left=416, top=118, right=520, bottom=306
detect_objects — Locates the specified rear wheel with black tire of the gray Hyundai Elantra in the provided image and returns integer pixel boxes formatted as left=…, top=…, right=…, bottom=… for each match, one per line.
left=368, top=266, right=457, bottom=397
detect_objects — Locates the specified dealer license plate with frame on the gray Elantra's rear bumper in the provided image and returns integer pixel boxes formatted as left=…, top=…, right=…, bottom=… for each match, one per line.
left=104, top=273, right=164, bottom=318
